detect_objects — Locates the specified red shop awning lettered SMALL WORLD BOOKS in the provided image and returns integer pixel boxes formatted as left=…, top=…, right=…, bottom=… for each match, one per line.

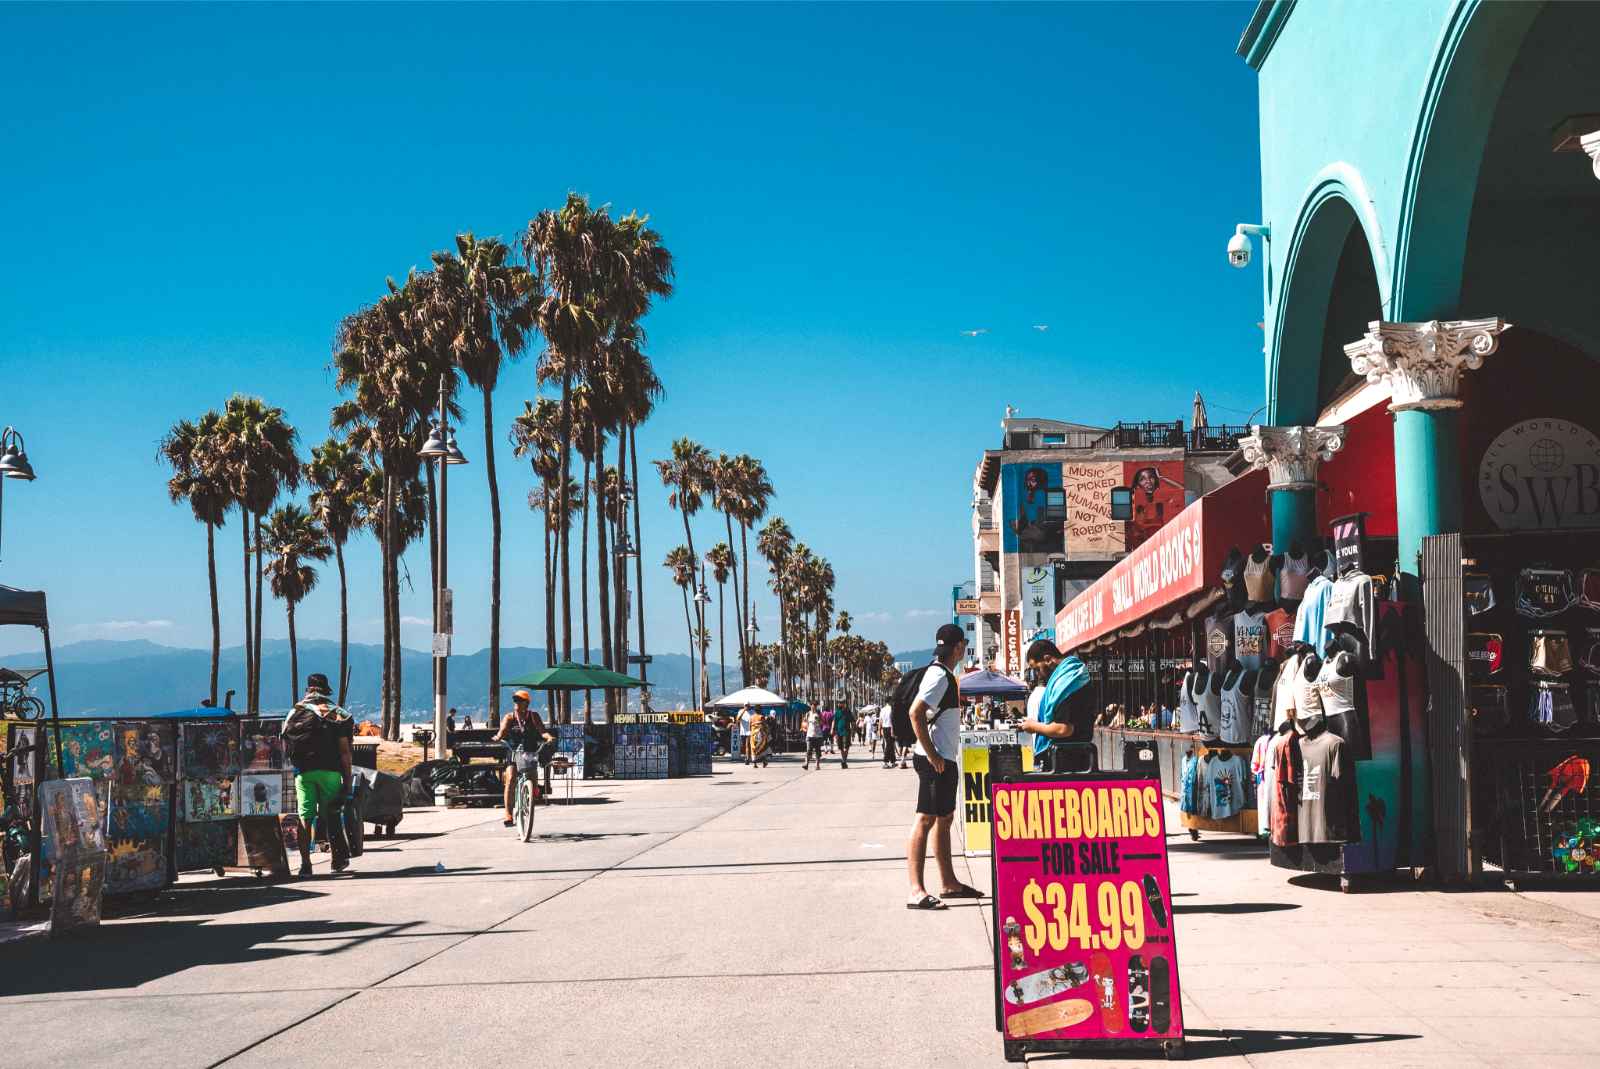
left=1056, top=472, right=1270, bottom=651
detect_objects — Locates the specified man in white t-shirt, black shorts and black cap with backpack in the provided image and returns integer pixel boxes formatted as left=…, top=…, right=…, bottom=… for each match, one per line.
left=906, top=624, right=982, bottom=909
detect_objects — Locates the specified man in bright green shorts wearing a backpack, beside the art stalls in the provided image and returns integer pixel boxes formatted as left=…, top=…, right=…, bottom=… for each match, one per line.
left=282, top=672, right=355, bottom=875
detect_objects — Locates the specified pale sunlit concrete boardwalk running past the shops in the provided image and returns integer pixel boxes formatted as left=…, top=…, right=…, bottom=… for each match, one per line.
left=0, top=759, right=1600, bottom=1069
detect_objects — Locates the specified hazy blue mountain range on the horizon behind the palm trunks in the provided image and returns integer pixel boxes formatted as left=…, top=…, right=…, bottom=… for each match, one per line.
left=0, top=639, right=933, bottom=720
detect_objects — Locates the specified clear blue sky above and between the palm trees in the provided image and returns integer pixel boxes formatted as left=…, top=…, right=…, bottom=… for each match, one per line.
left=0, top=3, right=1261, bottom=662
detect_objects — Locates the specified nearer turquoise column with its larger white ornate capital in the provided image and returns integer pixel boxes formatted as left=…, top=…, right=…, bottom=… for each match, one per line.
left=1344, top=317, right=1510, bottom=597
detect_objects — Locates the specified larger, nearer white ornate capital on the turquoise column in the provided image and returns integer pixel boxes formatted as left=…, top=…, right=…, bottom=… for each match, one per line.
left=1344, top=317, right=1510, bottom=411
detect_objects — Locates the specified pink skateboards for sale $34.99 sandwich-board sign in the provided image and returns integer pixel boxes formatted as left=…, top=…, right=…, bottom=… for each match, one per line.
left=989, top=775, right=1184, bottom=1058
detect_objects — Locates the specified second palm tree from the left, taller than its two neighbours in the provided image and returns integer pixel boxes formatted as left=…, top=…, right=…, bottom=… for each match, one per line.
left=219, top=394, right=299, bottom=712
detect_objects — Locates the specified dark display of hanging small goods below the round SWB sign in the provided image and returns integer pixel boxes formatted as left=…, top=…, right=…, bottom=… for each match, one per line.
left=1462, top=531, right=1600, bottom=887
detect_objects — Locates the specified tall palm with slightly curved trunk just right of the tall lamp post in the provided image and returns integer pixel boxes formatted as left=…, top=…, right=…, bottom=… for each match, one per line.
left=429, top=232, right=533, bottom=728
